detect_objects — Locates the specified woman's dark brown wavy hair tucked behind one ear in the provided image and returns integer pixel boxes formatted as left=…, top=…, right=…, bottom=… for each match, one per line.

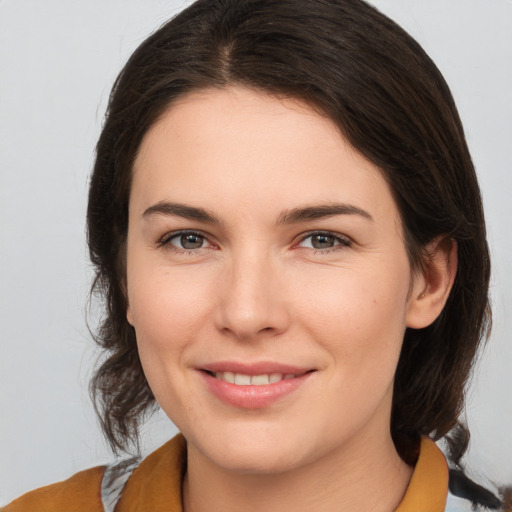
left=87, top=0, right=490, bottom=484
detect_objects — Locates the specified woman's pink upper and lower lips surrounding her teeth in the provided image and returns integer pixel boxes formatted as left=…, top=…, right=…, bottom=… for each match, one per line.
left=198, top=361, right=315, bottom=409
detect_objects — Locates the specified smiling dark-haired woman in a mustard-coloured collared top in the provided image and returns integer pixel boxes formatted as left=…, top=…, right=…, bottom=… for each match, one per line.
left=6, top=0, right=508, bottom=511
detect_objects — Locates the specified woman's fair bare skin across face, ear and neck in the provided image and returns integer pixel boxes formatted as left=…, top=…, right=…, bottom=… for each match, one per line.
left=127, top=87, right=456, bottom=512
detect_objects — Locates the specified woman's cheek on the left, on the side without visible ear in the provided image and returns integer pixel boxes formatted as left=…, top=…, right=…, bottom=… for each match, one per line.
left=128, top=268, right=216, bottom=416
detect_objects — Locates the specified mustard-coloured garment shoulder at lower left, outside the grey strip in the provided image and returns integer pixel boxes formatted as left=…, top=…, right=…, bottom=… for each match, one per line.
left=1, top=466, right=105, bottom=512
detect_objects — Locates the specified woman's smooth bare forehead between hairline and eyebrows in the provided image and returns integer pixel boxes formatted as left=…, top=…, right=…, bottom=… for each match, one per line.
left=132, top=87, right=396, bottom=228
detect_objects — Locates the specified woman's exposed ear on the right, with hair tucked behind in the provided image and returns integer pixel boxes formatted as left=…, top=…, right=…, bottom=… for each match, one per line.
left=406, top=236, right=457, bottom=329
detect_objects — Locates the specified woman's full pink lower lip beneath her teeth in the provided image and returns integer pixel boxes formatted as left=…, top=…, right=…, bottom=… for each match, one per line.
left=200, top=371, right=313, bottom=409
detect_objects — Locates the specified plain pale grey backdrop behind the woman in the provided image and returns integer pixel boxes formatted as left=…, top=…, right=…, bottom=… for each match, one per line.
left=0, top=0, right=512, bottom=503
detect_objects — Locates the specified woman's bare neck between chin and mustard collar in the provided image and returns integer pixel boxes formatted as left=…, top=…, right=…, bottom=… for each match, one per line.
left=183, top=435, right=412, bottom=512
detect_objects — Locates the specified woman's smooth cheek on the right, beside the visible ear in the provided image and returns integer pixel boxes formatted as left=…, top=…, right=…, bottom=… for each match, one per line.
left=295, top=264, right=408, bottom=368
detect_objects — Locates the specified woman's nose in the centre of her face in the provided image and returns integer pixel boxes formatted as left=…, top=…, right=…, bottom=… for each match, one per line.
left=216, top=249, right=290, bottom=341
